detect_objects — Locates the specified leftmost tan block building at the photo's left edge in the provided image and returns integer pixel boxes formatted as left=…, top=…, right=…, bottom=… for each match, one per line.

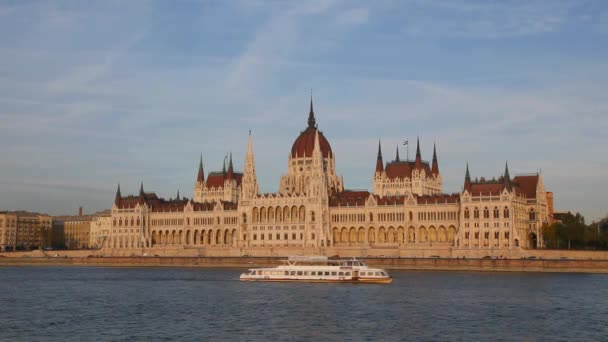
left=0, top=211, right=51, bottom=251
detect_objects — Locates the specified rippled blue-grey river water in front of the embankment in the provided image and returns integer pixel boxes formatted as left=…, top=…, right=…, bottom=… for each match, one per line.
left=0, top=267, right=608, bottom=341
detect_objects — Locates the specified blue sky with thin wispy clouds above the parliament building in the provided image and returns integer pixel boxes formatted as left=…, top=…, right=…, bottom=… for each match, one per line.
left=0, top=0, right=608, bottom=222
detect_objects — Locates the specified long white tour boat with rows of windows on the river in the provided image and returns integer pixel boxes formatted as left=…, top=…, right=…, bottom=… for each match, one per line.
left=240, top=256, right=393, bottom=284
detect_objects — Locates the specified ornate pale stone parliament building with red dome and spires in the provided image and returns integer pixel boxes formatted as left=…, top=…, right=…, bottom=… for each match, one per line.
left=103, top=99, right=552, bottom=257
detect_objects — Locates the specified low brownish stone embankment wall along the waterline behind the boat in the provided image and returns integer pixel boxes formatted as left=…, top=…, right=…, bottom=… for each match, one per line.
left=0, top=257, right=608, bottom=273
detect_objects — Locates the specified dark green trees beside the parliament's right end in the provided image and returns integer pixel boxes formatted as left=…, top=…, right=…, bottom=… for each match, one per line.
left=543, top=212, right=608, bottom=250
